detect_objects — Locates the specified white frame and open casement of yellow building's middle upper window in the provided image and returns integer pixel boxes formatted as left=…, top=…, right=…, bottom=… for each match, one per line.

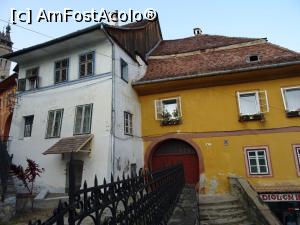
left=236, top=90, right=270, bottom=116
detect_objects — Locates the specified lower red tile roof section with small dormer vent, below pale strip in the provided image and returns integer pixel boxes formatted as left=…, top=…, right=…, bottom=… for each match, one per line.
left=136, top=41, right=300, bottom=84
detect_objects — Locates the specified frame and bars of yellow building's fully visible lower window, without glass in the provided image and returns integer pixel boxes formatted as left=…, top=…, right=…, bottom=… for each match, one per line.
left=244, top=146, right=272, bottom=177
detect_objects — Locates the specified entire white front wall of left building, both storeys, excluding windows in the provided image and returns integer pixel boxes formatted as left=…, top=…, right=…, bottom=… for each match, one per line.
left=9, top=36, right=112, bottom=192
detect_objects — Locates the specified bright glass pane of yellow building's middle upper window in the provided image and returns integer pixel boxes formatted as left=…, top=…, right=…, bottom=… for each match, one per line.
left=240, top=93, right=260, bottom=115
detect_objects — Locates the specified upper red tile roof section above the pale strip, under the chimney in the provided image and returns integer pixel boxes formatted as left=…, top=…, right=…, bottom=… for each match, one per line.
left=151, top=34, right=260, bottom=56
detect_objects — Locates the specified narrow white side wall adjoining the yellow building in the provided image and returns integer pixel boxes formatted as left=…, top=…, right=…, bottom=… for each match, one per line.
left=115, top=44, right=145, bottom=178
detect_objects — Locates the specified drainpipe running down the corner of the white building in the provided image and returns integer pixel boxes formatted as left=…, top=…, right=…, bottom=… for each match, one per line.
left=100, top=24, right=116, bottom=177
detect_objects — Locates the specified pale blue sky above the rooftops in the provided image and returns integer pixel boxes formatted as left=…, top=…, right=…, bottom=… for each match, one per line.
left=0, top=0, right=300, bottom=52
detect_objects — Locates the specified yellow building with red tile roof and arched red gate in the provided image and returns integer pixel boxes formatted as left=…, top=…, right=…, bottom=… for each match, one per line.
left=133, top=34, right=300, bottom=219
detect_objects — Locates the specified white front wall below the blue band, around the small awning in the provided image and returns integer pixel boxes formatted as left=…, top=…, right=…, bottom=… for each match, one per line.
left=9, top=76, right=111, bottom=191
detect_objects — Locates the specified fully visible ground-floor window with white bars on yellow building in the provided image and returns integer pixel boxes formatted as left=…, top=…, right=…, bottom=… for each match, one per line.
left=246, top=147, right=271, bottom=175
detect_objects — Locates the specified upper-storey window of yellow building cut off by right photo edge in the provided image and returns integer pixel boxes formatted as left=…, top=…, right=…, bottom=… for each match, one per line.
left=281, top=87, right=300, bottom=116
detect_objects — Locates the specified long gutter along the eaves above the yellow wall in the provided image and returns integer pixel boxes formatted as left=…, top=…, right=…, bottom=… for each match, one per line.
left=132, top=61, right=300, bottom=86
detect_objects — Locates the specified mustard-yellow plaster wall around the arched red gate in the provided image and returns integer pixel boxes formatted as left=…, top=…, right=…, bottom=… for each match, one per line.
left=140, top=77, right=300, bottom=192
